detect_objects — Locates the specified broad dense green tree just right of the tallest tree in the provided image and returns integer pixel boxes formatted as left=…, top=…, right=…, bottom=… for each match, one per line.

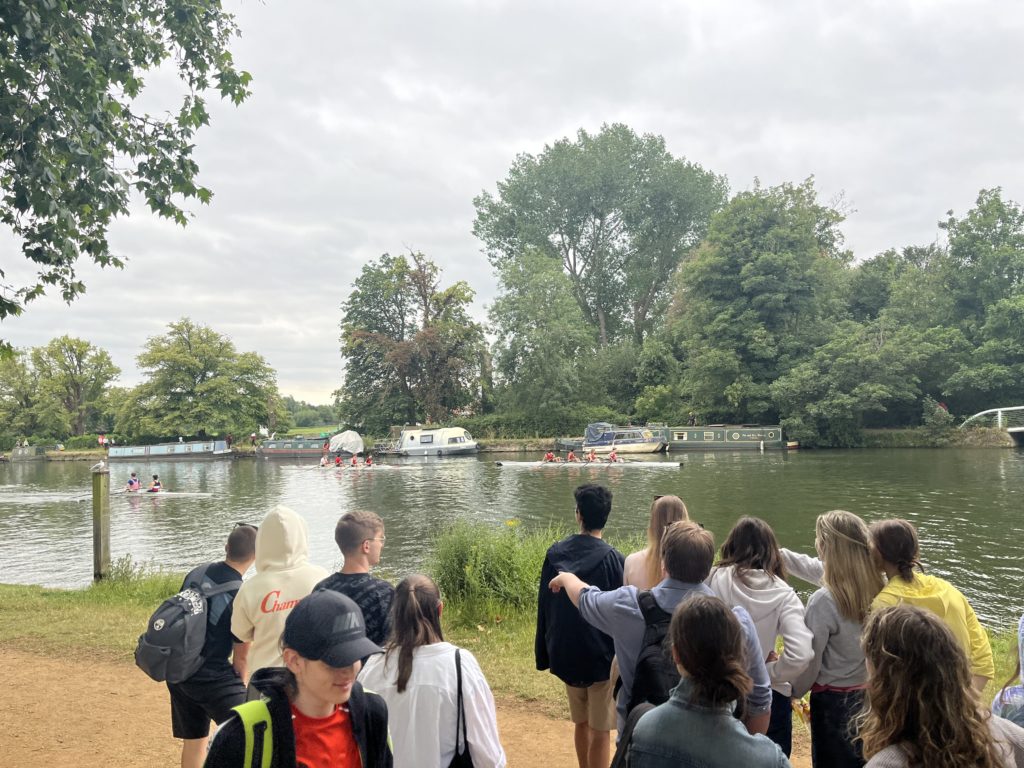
left=672, top=180, right=851, bottom=421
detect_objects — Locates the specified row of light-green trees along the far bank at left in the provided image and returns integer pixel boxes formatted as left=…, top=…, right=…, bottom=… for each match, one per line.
left=0, top=317, right=299, bottom=450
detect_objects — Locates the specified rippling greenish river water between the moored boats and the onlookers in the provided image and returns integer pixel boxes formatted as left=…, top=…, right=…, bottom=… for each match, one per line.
left=0, top=449, right=1024, bottom=627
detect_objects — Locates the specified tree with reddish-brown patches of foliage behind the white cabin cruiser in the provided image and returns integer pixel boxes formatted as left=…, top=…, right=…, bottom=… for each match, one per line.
left=335, top=253, right=483, bottom=433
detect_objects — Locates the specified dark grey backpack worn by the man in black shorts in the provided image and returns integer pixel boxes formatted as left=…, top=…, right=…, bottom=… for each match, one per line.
left=135, top=565, right=242, bottom=683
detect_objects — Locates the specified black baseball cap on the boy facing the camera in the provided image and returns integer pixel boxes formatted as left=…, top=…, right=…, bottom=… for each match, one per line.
left=283, top=590, right=384, bottom=667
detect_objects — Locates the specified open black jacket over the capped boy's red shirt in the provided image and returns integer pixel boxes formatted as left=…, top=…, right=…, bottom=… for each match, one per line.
left=204, top=668, right=392, bottom=768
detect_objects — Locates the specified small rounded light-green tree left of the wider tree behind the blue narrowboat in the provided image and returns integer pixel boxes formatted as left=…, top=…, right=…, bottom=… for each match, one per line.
left=32, top=336, right=121, bottom=435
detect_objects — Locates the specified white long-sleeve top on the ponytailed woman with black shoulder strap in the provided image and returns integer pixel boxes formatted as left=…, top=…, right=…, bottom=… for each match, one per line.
left=359, top=643, right=506, bottom=768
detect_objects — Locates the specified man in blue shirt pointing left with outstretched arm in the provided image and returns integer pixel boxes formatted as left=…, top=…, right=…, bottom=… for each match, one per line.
left=549, top=520, right=771, bottom=733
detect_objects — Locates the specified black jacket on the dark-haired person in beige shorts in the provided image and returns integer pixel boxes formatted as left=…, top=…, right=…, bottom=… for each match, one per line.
left=534, top=534, right=625, bottom=687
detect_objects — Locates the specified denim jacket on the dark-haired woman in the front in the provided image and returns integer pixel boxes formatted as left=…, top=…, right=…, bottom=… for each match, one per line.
left=629, top=676, right=790, bottom=768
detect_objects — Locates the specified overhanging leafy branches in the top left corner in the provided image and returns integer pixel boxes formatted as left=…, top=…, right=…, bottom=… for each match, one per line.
left=0, top=0, right=250, bottom=327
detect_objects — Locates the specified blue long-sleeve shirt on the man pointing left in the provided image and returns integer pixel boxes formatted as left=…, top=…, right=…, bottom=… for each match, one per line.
left=580, top=579, right=771, bottom=733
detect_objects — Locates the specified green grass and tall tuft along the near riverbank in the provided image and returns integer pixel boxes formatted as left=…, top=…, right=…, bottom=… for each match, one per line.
left=0, top=521, right=1017, bottom=717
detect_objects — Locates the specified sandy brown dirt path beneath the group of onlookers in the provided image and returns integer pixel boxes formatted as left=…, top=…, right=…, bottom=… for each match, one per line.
left=0, top=648, right=810, bottom=768
